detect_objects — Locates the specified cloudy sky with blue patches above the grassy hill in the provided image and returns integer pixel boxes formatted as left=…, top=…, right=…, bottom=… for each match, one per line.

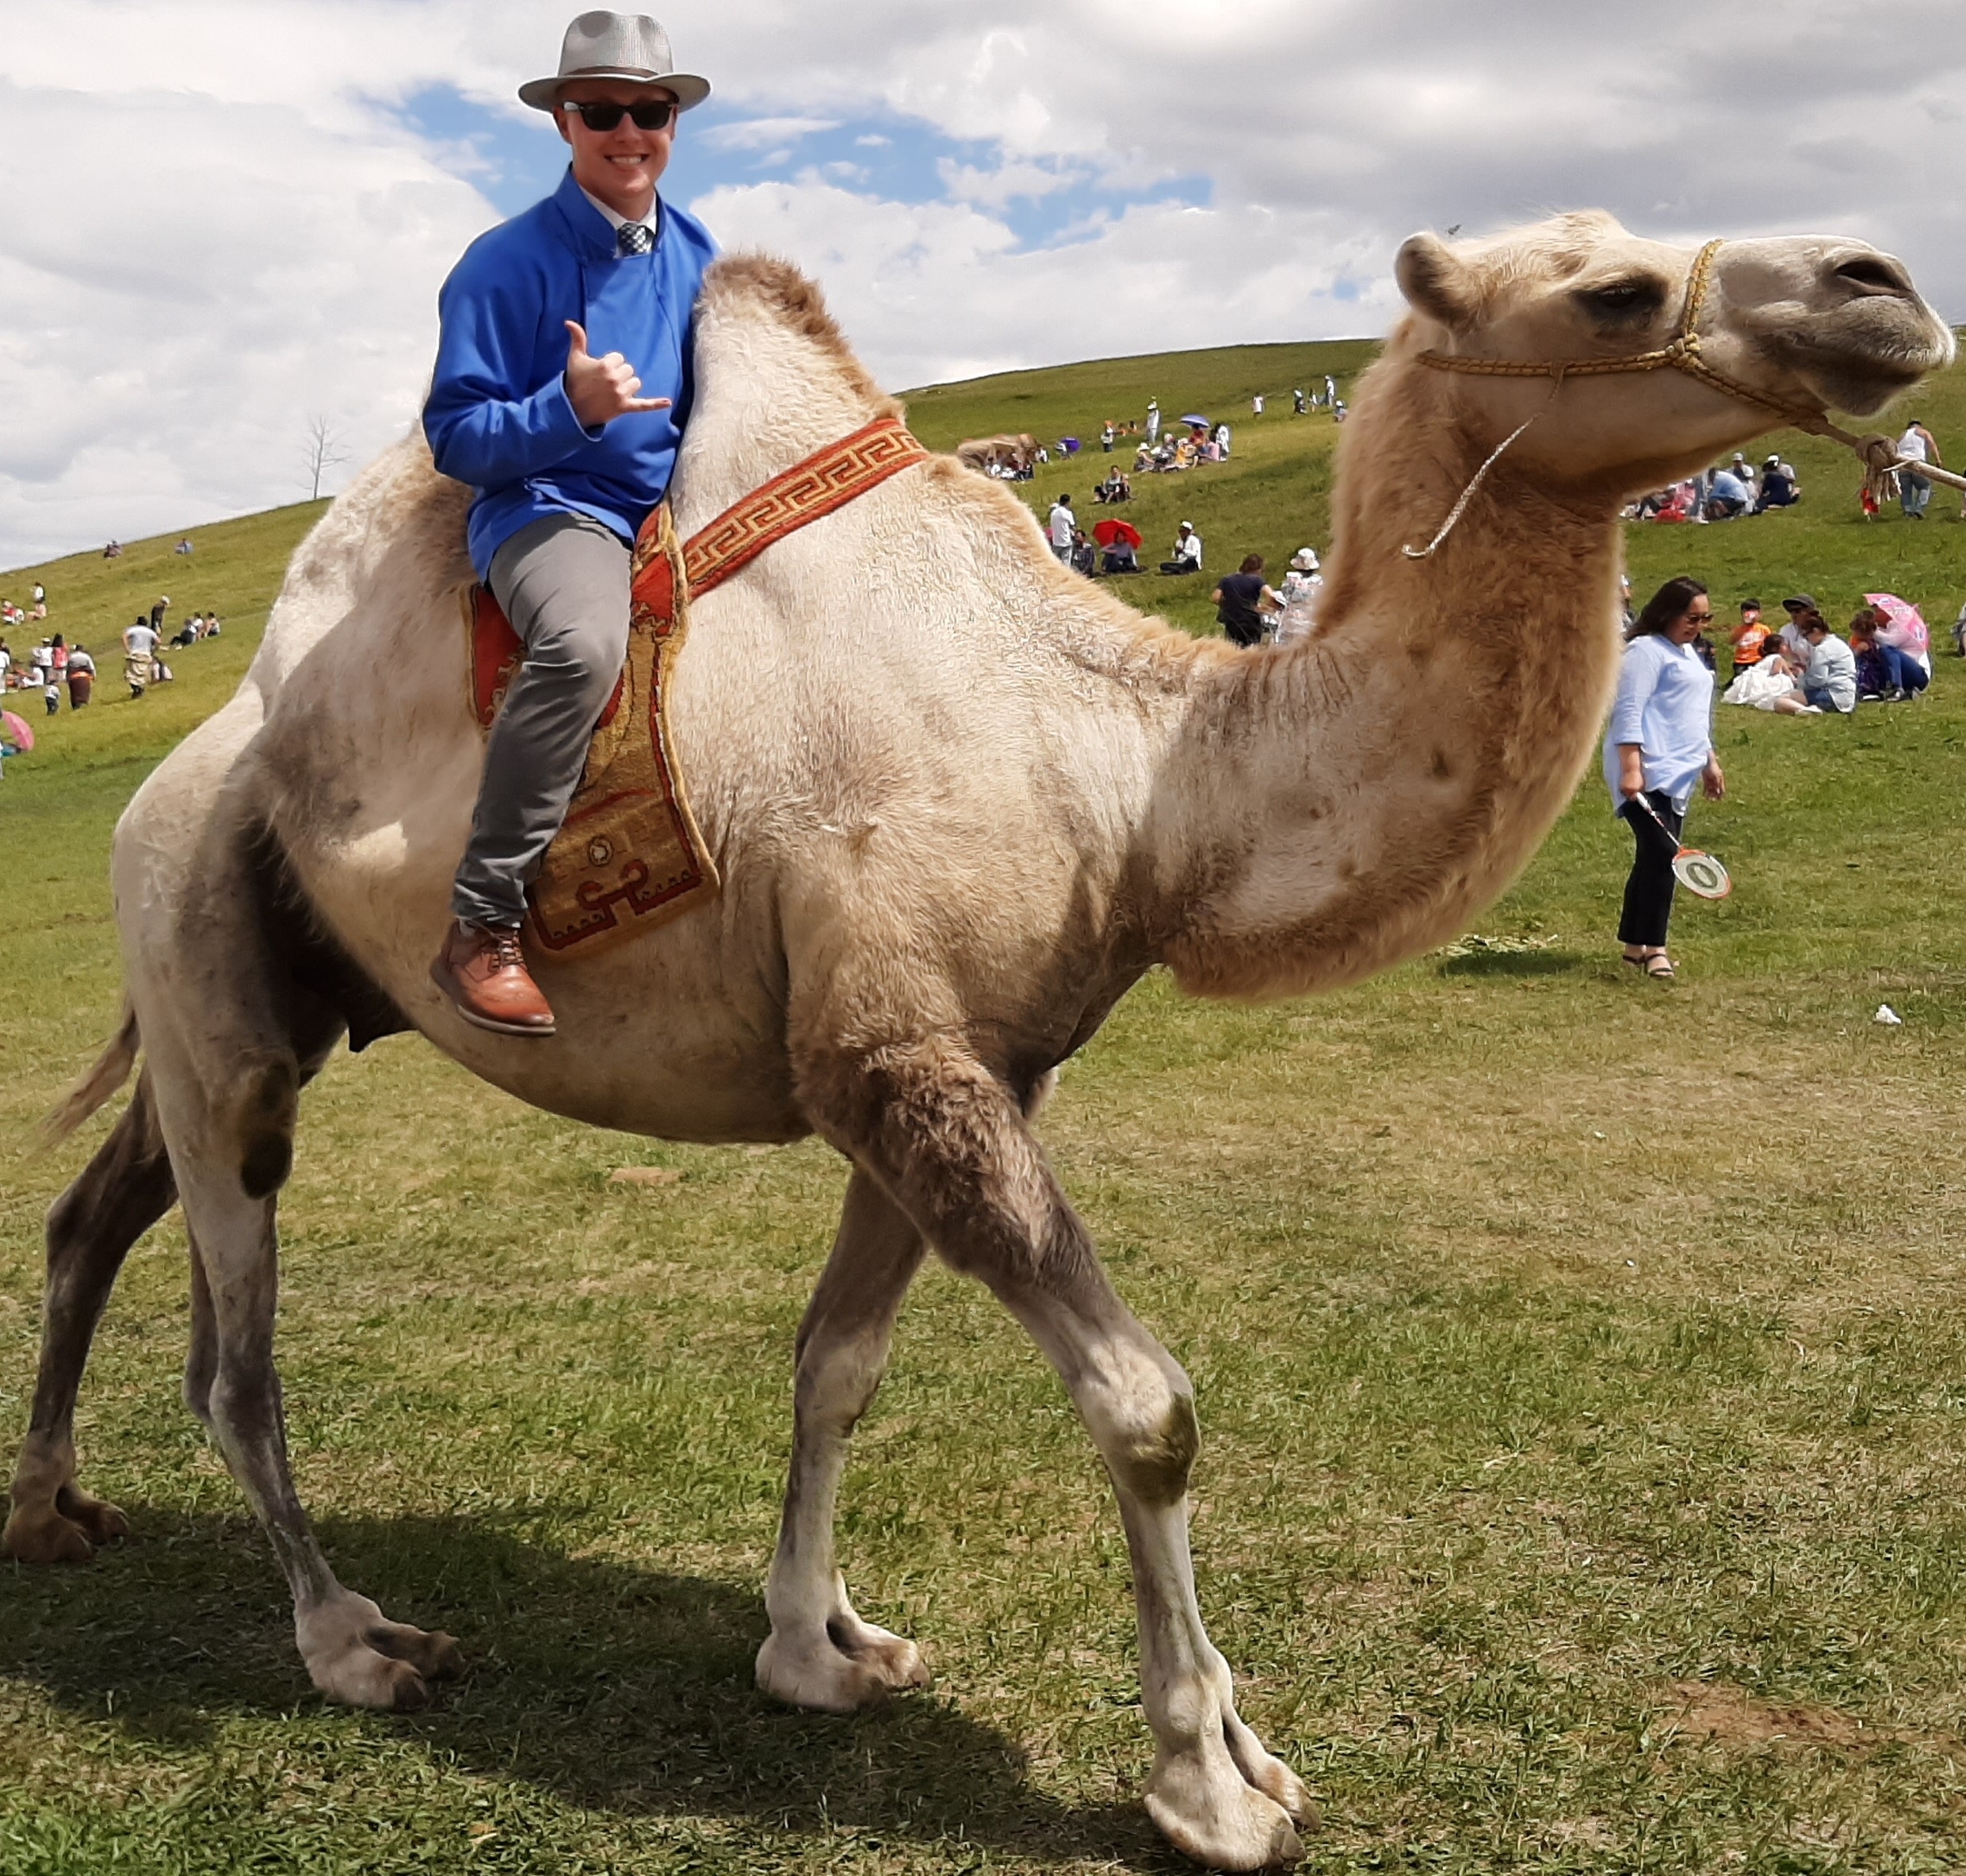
left=0, top=0, right=1966, bottom=567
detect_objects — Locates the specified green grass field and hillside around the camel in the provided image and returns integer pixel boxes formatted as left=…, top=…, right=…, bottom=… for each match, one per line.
left=0, top=348, right=1966, bottom=1876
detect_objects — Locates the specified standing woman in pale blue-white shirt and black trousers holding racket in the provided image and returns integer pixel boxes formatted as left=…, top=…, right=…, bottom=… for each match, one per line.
left=1604, top=578, right=1726, bottom=984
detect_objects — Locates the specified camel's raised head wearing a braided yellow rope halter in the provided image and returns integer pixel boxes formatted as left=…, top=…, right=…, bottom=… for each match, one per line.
left=1388, top=212, right=1954, bottom=499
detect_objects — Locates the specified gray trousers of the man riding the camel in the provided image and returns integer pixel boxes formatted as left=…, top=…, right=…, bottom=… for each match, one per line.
left=450, top=515, right=629, bottom=924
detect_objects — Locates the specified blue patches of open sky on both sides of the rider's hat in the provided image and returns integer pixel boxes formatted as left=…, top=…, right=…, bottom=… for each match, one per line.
left=385, top=85, right=1213, bottom=252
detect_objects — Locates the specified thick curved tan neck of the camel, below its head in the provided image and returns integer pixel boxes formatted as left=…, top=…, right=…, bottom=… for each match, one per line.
left=1154, top=365, right=1620, bottom=997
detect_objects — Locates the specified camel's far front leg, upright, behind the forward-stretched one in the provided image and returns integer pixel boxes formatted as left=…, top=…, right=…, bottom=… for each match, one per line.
left=757, top=1168, right=928, bottom=1713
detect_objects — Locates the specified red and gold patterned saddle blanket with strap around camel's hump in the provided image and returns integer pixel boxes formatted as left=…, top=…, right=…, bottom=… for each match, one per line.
left=464, top=417, right=928, bottom=957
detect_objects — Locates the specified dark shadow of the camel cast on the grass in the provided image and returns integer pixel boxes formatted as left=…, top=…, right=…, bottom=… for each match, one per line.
left=0, top=1507, right=1185, bottom=1870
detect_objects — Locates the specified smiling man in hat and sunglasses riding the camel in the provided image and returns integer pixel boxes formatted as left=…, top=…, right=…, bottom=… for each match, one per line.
left=422, top=12, right=716, bottom=1037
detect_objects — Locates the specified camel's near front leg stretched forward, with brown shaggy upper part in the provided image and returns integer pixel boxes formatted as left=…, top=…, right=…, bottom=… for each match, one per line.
left=806, top=1041, right=1315, bottom=1870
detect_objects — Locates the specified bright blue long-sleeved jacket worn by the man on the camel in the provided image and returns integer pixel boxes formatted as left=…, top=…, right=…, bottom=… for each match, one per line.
left=422, top=167, right=716, bottom=580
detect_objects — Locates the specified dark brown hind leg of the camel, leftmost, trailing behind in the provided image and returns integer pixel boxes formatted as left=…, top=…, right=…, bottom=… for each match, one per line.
left=0, top=1072, right=177, bottom=1564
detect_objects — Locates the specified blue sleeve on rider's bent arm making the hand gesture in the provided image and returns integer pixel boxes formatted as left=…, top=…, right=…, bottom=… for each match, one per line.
left=422, top=244, right=601, bottom=487
